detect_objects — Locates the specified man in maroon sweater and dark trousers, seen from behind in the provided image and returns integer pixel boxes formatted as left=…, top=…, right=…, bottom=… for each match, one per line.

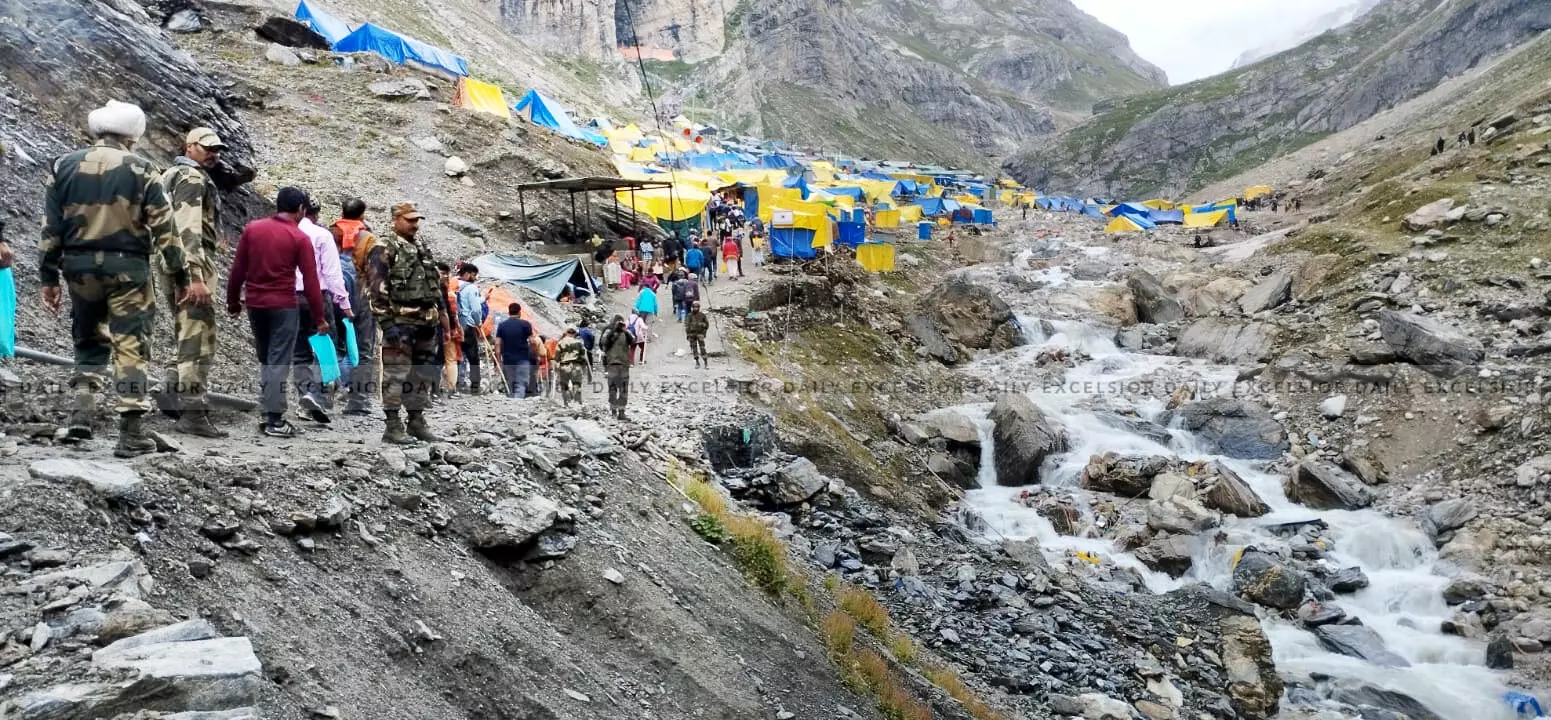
left=226, top=188, right=329, bottom=438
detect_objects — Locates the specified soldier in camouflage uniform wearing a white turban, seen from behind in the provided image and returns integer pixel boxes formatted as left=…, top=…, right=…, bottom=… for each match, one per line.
left=37, top=102, right=209, bottom=458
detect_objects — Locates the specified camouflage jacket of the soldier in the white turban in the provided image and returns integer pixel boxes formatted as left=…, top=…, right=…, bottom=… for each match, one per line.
left=37, top=138, right=189, bottom=287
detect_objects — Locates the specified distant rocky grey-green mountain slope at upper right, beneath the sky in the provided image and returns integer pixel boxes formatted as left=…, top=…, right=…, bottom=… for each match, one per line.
left=1007, top=0, right=1551, bottom=197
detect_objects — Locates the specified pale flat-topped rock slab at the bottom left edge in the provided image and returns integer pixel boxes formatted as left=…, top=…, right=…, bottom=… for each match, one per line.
left=92, top=638, right=264, bottom=711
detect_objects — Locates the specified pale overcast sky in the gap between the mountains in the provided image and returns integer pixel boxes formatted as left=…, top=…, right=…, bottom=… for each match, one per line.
left=1073, top=0, right=1352, bottom=85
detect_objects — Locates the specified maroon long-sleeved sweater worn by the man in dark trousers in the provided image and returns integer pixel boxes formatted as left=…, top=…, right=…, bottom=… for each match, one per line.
left=226, top=216, right=323, bottom=326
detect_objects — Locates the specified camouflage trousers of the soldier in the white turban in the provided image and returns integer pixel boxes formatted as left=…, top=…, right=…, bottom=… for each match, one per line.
left=62, top=259, right=155, bottom=413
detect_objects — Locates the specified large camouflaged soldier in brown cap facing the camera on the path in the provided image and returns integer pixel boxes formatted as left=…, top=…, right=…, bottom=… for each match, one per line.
left=363, top=203, right=451, bottom=445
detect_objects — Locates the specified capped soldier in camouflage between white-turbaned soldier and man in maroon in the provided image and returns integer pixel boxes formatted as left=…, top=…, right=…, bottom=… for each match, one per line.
left=155, top=127, right=226, bottom=438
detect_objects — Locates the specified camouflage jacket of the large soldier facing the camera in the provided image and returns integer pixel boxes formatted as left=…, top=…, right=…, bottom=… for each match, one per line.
left=363, top=233, right=447, bottom=324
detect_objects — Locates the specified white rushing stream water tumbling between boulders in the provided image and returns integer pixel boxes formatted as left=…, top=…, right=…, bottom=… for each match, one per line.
left=960, top=240, right=1517, bottom=720
